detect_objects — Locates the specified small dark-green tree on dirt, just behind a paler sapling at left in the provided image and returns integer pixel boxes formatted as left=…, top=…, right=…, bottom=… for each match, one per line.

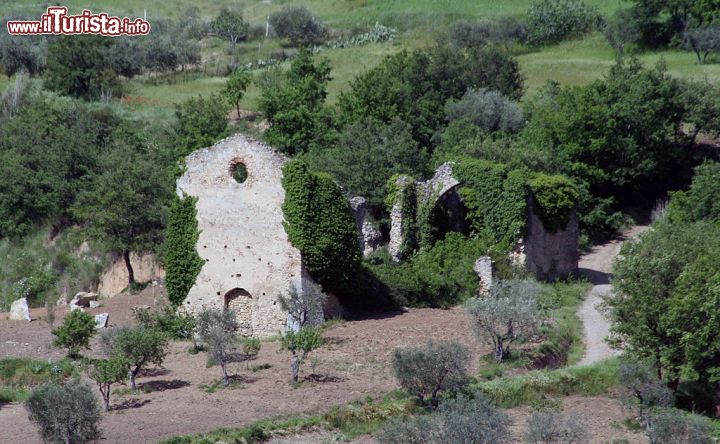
left=107, top=326, right=168, bottom=390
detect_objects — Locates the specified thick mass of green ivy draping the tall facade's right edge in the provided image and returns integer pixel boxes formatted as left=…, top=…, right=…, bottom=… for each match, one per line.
left=282, top=160, right=362, bottom=291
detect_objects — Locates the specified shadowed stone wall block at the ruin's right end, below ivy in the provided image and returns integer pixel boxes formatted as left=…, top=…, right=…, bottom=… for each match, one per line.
left=523, top=196, right=580, bottom=281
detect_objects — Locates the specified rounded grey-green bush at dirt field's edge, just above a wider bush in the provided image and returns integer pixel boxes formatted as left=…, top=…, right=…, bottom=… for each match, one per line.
left=392, top=340, right=470, bottom=407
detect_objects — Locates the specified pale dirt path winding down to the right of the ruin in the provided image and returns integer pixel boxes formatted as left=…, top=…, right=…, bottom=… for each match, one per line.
left=578, top=225, right=649, bottom=365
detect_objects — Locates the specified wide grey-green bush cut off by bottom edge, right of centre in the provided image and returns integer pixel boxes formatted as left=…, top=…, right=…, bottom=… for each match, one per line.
left=377, top=393, right=511, bottom=444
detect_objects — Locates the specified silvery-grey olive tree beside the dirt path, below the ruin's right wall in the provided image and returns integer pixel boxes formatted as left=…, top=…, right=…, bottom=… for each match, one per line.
left=465, top=279, right=539, bottom=362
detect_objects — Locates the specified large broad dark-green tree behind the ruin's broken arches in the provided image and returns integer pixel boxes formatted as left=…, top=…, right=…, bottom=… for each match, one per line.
left=338, top=45, right=523, bottom=147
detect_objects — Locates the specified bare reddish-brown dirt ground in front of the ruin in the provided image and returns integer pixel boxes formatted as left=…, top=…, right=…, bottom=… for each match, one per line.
left=0, top=287, right=634, bottom=443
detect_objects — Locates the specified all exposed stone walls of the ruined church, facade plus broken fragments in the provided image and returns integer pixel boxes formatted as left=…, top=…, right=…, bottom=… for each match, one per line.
left=177, top=135, right=579, bottom=337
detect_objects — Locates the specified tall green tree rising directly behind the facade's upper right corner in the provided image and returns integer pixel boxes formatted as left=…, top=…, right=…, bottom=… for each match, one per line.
left=258, top=50, right=333, bottom=155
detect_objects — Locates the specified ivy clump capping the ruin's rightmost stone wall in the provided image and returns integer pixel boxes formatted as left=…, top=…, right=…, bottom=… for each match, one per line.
left=530, top=174, right=580, bottom=233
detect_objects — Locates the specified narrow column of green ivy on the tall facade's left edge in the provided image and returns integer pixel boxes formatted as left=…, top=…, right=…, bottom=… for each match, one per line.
left=164, top=195, right=204, bottom=306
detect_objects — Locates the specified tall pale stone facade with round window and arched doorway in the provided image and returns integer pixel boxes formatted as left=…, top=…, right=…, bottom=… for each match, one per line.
left=177, top=135, right=318, bottom=337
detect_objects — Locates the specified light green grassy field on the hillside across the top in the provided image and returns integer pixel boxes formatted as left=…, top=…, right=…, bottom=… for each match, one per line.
left=0, top=0, right=720, bottom=120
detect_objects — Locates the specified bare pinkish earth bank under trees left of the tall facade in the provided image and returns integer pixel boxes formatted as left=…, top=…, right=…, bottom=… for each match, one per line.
left=98, top=253, right=165, bottom=297
